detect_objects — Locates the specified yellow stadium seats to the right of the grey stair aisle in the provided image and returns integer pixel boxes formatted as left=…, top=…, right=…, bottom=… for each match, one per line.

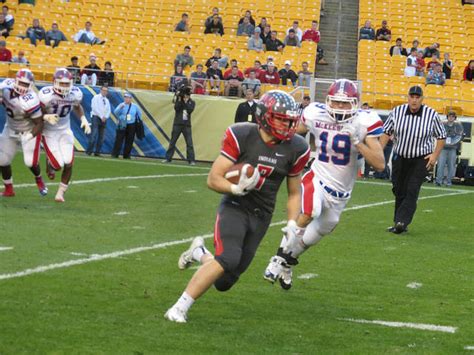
left=357, top=0, right=474, bottom=116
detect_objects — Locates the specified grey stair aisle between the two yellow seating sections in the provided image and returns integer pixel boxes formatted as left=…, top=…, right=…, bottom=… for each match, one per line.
left=316, top=0, right=359, bottom=80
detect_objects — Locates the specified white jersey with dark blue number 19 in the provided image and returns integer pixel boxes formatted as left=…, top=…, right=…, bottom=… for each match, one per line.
left=301, top=103, right=383, bottom=193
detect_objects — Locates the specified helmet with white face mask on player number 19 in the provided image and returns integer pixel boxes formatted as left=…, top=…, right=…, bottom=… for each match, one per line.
left=326, top=79, right=359, bottom=122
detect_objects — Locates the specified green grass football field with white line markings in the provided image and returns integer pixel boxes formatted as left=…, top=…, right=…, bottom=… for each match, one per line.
left=0, top=156, right=474, bottom=354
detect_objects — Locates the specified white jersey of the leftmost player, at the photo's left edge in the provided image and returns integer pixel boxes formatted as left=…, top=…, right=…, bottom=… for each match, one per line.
left=0, top=79, right=42, bottom=133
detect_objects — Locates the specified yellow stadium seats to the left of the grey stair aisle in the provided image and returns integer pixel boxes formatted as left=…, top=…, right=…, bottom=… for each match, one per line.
left=0, top=0, right=320, bottom=90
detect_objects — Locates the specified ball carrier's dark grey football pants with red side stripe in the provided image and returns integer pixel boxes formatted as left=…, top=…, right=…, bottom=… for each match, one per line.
left=214, top=201, right=271, bottom=291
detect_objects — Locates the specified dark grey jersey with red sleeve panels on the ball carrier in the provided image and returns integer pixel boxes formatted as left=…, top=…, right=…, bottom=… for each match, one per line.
left=221, top=122, right=310, bottom=213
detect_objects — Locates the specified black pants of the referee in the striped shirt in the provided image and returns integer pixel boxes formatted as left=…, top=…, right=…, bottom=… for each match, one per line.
left=392, top=155, right=428, bottom=226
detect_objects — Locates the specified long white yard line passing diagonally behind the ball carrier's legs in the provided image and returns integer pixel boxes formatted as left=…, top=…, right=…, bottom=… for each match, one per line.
left=0, top=192, right=469, bottom=280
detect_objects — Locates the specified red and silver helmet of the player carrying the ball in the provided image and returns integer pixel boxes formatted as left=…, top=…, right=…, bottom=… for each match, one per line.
left=255, top=90, right=298, bottom=140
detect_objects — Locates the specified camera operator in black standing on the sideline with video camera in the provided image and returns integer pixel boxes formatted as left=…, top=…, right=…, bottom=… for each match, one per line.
left=163, top=85, right=196, bottom=165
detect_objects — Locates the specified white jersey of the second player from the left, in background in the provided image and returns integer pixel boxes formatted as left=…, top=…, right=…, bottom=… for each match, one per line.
left=38, top=86, right=82, bottom=133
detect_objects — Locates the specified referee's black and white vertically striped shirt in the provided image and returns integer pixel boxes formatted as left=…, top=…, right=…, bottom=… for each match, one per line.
left=383, top=104, right=446, bottom=158
